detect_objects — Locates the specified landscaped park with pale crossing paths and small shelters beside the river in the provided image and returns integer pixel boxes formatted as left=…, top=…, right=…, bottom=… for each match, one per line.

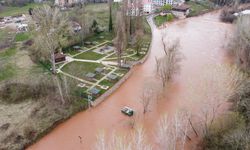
left=57, top=33, right=150, bottom=101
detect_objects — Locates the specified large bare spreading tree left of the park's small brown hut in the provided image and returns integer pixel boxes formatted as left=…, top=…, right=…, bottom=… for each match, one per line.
left=32, top=5, right=69, bottom=73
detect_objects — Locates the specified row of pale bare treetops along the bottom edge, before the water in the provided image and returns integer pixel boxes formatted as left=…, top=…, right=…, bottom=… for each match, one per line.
left=94, top=113, right=188, bottom=150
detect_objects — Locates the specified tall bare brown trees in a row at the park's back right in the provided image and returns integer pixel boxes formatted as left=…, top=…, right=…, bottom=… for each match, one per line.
left=114, top=0, right=144, bottom=66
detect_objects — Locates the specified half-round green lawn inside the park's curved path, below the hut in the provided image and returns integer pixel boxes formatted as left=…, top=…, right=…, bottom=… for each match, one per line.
left=62, top=61, right=104, bottom=79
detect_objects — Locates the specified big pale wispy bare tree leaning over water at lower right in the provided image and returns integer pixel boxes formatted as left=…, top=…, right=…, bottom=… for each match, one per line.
left=187, top=65, right=246, bottom=136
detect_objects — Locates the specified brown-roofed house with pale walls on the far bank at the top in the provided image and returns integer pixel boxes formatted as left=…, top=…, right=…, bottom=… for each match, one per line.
left=172, top=4, right=190, bottom=18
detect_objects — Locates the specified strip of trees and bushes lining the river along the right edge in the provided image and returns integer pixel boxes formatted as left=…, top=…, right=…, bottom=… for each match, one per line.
left=203, top=12, right=250, bottom=150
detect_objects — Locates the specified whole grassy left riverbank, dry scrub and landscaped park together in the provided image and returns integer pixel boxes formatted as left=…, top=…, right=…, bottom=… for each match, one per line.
left=0, top=3, right=151, bottom=149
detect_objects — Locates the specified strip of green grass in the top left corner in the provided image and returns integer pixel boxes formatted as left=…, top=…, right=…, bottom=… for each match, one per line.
left=0, top=3, right=42, bottom=17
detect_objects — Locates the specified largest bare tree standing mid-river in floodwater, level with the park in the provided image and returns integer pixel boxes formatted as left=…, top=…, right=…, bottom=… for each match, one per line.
left=156, top=37, right=182, bottom=87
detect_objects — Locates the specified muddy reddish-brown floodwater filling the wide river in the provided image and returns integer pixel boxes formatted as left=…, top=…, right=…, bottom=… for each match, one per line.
left=28, top=12, right=233, bottom=150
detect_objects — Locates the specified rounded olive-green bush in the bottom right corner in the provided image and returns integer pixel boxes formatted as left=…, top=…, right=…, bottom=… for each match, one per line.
left=203, top=113, right=249, bottom=150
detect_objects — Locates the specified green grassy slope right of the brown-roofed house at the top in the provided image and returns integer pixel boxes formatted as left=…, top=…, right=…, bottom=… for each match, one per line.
left=187, top=1, right=213, bottom=17
